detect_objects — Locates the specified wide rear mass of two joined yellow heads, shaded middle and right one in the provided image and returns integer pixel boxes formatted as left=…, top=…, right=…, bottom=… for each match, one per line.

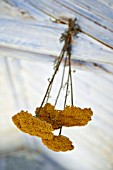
left=35, top=103, right=93, bottom=129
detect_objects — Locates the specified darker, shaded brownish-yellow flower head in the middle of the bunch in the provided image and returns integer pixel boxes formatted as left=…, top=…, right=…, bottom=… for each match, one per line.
left=35, top=103, right=61, bottom=130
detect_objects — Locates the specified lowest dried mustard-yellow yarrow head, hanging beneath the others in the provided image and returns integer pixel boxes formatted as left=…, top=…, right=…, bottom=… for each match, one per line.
left=42, top=135, right=74, bottom=152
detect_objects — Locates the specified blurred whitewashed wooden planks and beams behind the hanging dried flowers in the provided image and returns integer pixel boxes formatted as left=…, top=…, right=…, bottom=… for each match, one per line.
left=0, top=0, right=113, bottom=170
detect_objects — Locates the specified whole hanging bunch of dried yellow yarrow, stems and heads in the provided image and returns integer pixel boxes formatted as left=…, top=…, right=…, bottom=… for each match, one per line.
left=12, top=19, right=93, bottom=152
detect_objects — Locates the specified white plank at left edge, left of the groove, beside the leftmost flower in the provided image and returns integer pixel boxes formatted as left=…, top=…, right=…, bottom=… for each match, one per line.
left=0, top=57, right=24, bottom=154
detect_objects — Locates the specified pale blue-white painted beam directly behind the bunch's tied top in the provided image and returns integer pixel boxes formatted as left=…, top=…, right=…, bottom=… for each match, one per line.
left=0, top=18, right=113, bottom=64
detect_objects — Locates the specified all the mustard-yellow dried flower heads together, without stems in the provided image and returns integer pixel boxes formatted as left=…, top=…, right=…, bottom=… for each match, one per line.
left=12, top=103, right=93, bottom=152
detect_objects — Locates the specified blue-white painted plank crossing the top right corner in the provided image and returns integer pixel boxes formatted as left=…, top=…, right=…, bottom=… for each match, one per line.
left=55, top=0, right=113, bottom=32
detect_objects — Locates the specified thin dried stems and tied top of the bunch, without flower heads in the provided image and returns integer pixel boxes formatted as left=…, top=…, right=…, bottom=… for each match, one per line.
left=36, top=18, right=81, bottom=135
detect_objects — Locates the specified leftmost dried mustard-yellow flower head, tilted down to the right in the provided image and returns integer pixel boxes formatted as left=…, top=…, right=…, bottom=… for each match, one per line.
left=12, top=111, right=53, bottom=139
